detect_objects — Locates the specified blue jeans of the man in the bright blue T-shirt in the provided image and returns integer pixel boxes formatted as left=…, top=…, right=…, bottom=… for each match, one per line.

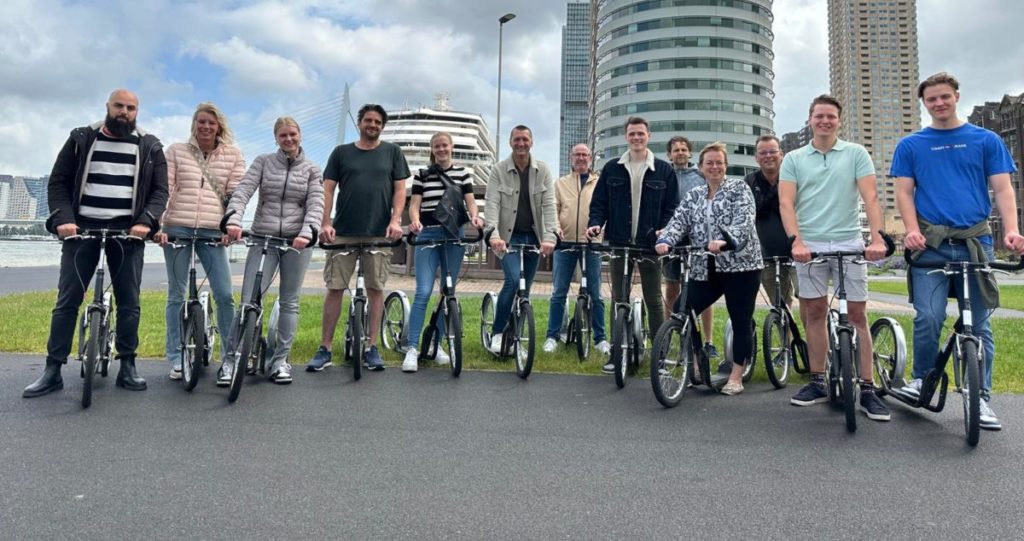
left=910, top=241, right=995, bottom=397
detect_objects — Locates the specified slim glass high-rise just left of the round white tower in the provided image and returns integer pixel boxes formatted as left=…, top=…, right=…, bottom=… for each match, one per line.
left=558, top=0, right=592, bottom=175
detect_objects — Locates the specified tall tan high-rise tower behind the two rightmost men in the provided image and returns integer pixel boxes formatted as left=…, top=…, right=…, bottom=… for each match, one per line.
left=828, top=0, right=921, bottom=232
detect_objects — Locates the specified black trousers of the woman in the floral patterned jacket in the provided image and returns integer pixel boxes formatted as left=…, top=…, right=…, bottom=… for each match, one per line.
left=686, top=265, right=761, bottom=365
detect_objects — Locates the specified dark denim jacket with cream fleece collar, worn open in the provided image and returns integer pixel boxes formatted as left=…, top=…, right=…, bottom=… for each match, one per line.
left=587, top=151, right=679, bottom=244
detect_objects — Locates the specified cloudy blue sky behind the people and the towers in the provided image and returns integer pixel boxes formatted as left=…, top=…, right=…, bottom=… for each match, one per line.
left=0, top=0, right=1024, bottom=175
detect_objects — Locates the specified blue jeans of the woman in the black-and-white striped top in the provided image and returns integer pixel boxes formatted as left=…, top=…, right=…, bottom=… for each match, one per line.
left=408, top=225, right=466, bottom=348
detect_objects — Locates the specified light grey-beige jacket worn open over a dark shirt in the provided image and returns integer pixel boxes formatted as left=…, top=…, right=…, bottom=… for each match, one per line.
left=483, top=157, right=558, bottom=250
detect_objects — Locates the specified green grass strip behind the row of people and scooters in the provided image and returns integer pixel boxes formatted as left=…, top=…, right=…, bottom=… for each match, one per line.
left=6, top=288, right=1024, bottom=392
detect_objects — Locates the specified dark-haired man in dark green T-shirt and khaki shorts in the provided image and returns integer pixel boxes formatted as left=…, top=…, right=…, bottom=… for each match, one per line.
left=306, top=105, right=411, bottom=372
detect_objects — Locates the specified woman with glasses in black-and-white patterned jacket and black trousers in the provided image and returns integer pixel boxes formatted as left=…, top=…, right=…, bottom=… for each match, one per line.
left=655, top=142, right=764, bottom=394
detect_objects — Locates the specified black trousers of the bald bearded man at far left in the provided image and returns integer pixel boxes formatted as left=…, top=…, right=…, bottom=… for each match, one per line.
left=46, top=239, right=145, bottom=363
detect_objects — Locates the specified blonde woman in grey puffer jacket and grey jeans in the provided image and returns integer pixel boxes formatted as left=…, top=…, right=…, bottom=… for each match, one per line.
left=224, top=117, right=324, bottom=386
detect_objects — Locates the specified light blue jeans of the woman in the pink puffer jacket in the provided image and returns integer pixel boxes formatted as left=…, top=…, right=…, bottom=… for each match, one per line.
left=163, top=225, right=234, bottom=366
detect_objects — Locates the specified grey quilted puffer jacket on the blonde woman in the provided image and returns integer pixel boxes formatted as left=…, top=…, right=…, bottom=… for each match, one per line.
left=227, top=149, right=324, bottom=240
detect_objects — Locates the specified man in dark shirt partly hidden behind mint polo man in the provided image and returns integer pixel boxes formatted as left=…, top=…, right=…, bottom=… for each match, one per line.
left=743, top=135, right=796, bottom=306
